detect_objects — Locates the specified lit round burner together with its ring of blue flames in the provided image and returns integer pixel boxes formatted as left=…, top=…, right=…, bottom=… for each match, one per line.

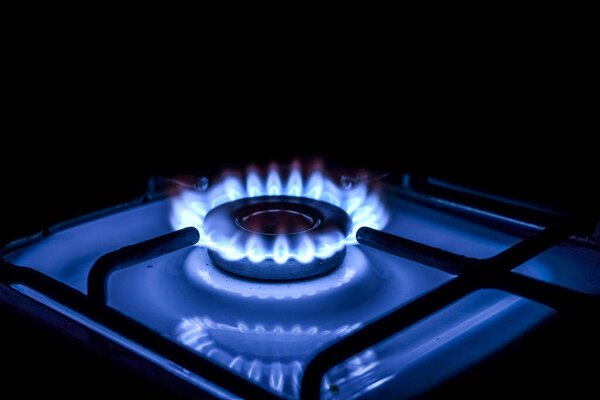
left=171, top=163, right=389, bottom=281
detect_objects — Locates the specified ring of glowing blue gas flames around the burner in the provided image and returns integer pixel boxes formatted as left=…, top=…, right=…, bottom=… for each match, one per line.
left=171, top=167, right=389, bottom=264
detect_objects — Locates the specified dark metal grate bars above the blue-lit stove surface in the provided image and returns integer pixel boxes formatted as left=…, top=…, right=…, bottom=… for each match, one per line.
left=0, top=178, right=600, bottom=399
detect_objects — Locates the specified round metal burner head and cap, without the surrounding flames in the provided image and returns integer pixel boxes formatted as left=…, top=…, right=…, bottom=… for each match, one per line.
left=204, top=196, right=352, bottom=280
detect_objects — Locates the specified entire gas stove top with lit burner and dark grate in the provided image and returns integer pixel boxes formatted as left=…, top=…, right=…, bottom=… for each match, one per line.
left=0, top=163, right=600, bottom=400
